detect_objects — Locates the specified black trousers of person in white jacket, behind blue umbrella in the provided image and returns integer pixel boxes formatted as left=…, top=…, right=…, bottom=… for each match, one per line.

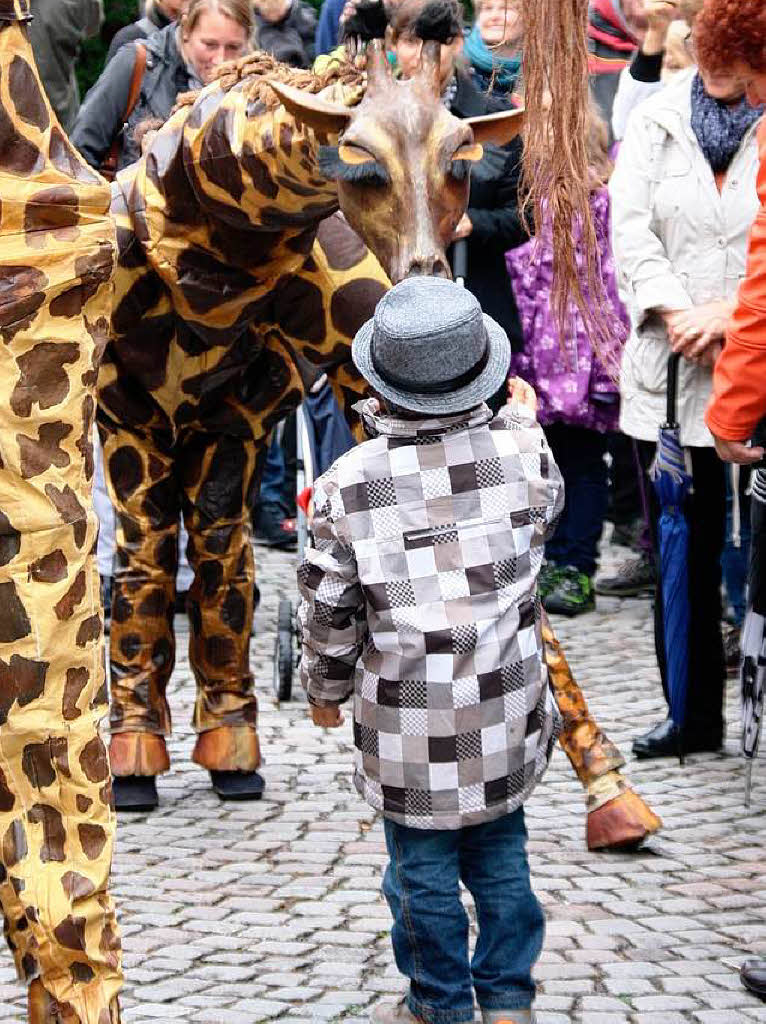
left=639, top=441, right=726, bottom=738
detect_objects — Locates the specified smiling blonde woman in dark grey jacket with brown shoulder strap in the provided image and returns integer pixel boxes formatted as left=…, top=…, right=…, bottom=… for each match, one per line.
left=72, top=0, right=254, bottom=170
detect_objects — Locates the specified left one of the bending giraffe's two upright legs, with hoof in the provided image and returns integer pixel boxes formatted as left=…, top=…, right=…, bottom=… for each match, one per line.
left=99, top=417, right=181, bottom=778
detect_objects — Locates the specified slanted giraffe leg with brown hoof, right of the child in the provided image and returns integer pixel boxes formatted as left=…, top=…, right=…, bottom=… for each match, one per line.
left=543, top=616, right=663, bottom=850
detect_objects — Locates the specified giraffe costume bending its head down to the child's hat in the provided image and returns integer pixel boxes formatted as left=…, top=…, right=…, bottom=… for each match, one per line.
left=98, top=36, right=658, bottom=845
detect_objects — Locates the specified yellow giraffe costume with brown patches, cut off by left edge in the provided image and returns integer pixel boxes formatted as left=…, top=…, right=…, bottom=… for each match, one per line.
left=0, top=0, right=121, bottom=1024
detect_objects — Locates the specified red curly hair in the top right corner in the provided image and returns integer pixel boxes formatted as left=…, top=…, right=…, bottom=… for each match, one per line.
left=694, top=0, right=766, bottom=73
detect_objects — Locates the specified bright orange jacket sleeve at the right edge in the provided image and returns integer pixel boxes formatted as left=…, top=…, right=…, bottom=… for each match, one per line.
left=705, top=120, right=766, bottom=441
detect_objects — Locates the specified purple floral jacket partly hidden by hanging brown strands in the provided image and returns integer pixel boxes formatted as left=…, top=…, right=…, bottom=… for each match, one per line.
left=505, top=188, right=630, bottom=431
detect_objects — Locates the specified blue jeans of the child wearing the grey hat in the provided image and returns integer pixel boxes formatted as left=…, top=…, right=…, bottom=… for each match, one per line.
left=383, top=808, right=545, bottom=1024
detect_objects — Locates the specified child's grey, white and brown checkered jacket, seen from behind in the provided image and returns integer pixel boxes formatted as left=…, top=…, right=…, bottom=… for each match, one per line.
left=298, top=399, right=563, bottom=828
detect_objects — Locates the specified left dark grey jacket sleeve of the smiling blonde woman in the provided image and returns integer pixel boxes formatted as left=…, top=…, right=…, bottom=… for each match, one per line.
left=71, top=45, right=136, bottom=168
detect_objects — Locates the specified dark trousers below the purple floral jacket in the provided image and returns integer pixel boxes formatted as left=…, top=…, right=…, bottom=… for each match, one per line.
left=545, top=423, right=608, bottom=577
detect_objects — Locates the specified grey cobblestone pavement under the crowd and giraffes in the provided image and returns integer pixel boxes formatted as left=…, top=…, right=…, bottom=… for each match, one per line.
left=0, top=536, right=766, bottom=1024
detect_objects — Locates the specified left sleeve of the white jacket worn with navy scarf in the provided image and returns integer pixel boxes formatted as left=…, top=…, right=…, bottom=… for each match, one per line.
left=609, top=107, right=693, bottom=315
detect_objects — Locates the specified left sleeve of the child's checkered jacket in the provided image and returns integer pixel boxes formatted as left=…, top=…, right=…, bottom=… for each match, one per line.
left=298, top=471, right=366, bottom=707
